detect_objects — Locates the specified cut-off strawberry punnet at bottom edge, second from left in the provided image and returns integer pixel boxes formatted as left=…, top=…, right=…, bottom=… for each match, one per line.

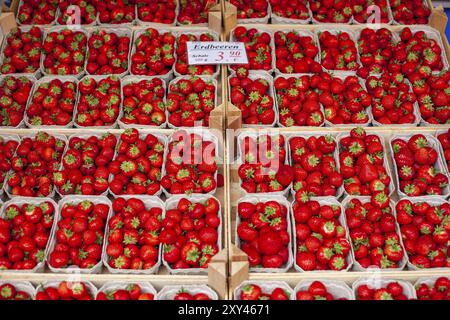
left=36, top=281, right=95, bottom=300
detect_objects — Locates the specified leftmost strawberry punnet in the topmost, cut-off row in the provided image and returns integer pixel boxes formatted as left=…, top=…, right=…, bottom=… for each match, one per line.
left=17, top=0, right=59, bottom=25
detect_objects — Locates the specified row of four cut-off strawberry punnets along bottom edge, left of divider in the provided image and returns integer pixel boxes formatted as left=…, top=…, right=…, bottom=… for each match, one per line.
left=0, top=280, right=218, bottom=300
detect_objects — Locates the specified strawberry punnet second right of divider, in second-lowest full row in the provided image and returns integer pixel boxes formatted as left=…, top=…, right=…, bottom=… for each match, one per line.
left=289, top=135, right=343, bottom=197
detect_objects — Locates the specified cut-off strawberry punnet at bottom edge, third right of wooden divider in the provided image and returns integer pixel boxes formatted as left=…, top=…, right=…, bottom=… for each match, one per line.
left=355, top=281, right=412, bottom=300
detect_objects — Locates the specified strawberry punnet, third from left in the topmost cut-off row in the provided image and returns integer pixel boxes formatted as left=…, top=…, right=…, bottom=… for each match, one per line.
left=97, top=0, right=136, bottom=24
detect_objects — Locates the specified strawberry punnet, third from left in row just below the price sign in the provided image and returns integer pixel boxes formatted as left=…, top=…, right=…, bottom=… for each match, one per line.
left=75, top=75, right=121, bottom=127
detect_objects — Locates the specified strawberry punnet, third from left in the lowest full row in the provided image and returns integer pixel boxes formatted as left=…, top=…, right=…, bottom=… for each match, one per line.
left=105, top=198, right=163, bottom=270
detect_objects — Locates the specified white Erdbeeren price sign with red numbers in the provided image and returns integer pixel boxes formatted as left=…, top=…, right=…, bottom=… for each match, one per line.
left=186, top=41, right=248, bottom=65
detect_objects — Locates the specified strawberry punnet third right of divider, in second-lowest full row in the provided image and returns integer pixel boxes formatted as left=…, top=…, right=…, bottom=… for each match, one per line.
left=339, top=127, right=394, bottom=196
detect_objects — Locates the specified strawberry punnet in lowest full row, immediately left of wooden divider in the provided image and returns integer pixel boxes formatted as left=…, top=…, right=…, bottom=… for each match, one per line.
left=159, top=197, right=222, bottom=269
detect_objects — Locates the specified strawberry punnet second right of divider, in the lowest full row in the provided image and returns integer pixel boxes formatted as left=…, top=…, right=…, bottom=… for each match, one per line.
left=292, top=199, right=351, bottom=271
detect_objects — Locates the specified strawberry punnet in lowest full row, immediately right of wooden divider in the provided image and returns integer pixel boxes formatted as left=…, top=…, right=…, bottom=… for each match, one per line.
left=237, top=198, right=292, bottom=269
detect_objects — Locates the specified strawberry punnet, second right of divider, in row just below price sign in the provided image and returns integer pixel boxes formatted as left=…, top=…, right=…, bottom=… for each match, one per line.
left=274, top=73, right=324, bottom=127
